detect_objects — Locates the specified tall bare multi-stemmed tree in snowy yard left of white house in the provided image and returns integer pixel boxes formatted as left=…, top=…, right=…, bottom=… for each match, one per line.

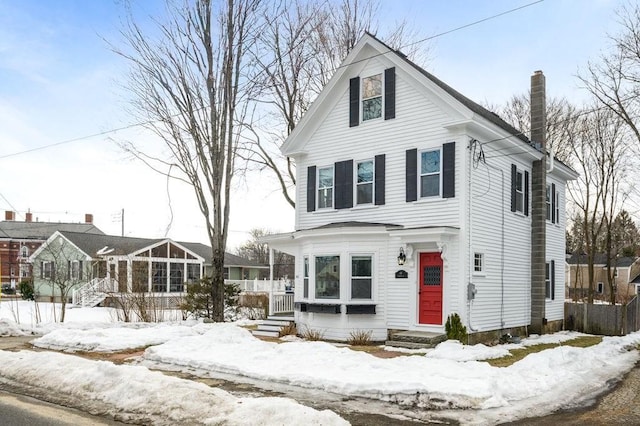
left=112, top=0, right=261, bottom=321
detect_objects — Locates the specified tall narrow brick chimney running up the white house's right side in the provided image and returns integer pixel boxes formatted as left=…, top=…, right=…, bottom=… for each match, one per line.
left=529, top=71, right=547, bottom=334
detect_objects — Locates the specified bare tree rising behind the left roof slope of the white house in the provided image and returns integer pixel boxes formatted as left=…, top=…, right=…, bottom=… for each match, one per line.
left=242, top=0, right=428, bottom=207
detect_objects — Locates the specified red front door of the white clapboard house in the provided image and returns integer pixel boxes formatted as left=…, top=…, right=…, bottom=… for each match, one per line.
left=418, top=252, right=442, bottom=325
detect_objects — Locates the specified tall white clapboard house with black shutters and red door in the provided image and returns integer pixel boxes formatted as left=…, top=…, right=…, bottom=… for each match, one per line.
left=265, top=34, right=577, bottom=340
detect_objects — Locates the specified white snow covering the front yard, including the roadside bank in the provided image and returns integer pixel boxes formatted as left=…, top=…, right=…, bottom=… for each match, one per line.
left=0, top=302, right=640, bottom=424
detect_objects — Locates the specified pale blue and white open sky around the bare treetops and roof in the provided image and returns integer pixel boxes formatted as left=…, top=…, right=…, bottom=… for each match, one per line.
left=0, top=0, right=621, bottom=251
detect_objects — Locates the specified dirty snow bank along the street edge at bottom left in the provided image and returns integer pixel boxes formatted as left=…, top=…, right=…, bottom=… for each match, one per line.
left=0, top=351, right=348, bottom=425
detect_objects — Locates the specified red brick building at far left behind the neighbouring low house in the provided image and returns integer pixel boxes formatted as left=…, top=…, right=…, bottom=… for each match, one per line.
left=0, top=211, right=104, bottom=288
